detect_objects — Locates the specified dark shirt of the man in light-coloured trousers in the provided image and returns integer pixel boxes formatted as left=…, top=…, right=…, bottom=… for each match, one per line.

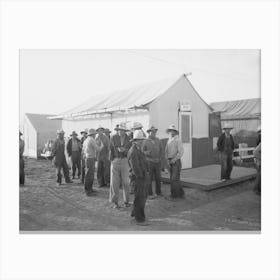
left=110, top=134, right=131, bottom=160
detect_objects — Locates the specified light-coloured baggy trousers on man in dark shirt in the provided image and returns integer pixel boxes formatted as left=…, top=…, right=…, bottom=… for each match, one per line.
left=109, top=158, right=129, bottom=204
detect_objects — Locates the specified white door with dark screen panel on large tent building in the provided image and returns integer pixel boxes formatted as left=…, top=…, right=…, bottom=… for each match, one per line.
left=179, top=112, right=192, bottom=169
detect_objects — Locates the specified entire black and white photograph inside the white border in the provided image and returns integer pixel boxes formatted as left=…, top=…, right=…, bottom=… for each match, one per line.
left=19, top=49, right=261, bottom=233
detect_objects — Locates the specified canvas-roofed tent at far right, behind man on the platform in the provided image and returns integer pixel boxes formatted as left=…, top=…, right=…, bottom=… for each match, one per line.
left=210, top=98, right=261, bottom=134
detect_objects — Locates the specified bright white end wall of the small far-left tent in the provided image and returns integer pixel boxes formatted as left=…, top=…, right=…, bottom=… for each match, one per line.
left=23, top=117, right=37, bottom=158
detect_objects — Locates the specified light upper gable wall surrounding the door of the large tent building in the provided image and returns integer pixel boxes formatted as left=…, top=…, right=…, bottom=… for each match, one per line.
left=149, top=75, right=210, bottom=138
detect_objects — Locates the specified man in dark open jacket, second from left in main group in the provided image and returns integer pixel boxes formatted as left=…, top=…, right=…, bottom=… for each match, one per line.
left=66, top=131, right=82, bottom=179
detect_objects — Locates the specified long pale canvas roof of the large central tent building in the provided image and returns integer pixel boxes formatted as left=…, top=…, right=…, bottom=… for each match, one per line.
left=52, top=74, right=208, bottom=118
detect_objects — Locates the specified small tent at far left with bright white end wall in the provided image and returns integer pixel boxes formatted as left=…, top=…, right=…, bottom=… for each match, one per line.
left=22, top=114, right=61, bottom=158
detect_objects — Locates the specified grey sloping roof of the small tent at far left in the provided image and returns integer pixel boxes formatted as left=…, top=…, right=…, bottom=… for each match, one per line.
left=25, top=113, right=61, bottom=132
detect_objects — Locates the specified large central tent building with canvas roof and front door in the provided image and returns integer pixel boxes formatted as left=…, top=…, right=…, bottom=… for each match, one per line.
left=52, top=74, right=220, bottom=168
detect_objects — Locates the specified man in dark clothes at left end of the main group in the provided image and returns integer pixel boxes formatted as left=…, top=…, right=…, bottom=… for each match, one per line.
left=52, top=130, right=72, bottom=185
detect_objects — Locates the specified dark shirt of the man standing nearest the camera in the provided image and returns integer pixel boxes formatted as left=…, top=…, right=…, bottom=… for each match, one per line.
left=127, top=144, right=148, bottom=178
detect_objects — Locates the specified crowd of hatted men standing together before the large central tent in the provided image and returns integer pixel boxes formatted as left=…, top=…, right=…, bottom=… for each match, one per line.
left=49, top=123, right=184, bottom=224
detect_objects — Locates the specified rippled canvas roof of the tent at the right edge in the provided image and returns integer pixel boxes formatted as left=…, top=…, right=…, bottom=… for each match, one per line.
left=210, top=98, right=261, bottom=120
